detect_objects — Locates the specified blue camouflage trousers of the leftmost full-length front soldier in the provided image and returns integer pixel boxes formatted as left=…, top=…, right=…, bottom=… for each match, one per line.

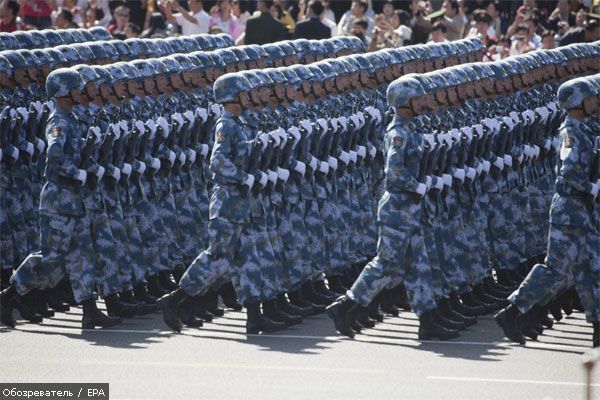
left=10, top=211, right=95, bottom=303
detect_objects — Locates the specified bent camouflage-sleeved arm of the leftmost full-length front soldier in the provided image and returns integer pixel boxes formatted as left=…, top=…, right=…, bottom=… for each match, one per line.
left=46, top=120, right=79, bottom=179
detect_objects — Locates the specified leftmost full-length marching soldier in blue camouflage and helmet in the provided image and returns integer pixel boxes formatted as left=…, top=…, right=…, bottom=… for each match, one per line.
left=1, top=69, right=121, bottom=329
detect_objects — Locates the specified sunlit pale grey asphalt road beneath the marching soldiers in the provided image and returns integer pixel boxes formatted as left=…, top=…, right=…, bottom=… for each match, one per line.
left=0, top=309, right=600, bottom=400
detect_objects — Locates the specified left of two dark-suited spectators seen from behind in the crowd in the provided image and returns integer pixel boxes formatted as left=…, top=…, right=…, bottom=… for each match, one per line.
left=244, top=0, right=288, bottom=44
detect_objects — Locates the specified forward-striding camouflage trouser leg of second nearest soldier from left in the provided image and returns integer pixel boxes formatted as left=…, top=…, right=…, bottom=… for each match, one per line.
left=179, top=218, right=243, bottom=296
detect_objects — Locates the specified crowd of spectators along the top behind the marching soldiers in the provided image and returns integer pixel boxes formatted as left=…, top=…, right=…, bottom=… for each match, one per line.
left=0, top=0, right=600, bottom=56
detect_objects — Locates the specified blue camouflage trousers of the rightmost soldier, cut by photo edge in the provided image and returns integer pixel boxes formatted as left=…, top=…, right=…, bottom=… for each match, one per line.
left=508, top=225, right=600, bottom=322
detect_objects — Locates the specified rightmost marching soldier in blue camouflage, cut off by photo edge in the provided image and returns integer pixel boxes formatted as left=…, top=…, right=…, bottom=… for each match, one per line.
left=495, top=78, right=600, bottom=346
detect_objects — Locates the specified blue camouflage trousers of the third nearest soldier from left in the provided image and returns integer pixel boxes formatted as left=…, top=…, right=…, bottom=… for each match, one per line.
left=347, top=225, right=437, bottom=316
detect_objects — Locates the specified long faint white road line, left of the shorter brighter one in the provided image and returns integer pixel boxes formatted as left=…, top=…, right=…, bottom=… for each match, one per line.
left=80, top=361, right=386, bottom=374
